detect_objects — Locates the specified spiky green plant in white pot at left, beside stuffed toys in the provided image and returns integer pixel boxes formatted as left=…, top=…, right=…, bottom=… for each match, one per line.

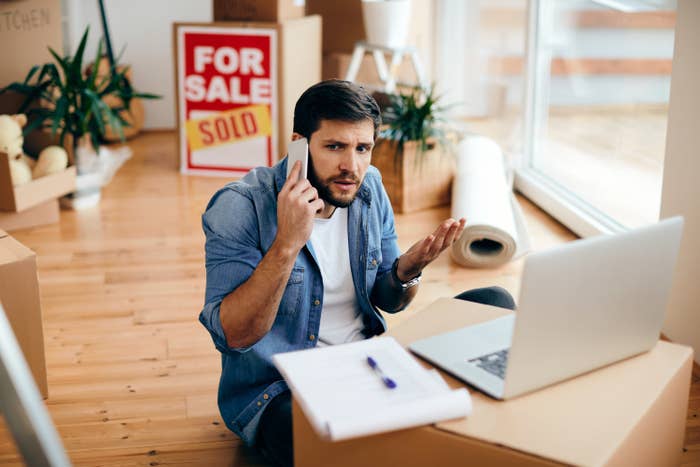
left=0, top=28, right=159, bottom=207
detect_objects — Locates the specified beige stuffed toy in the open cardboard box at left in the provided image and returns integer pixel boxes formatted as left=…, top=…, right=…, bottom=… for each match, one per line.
left=0, top=114, right=68, bottom=186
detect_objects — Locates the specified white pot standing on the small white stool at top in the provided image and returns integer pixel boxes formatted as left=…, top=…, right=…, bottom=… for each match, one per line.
left=362, top=0, right=411, bottom=48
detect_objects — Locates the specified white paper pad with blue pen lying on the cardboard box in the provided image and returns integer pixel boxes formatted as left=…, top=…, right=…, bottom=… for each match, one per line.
left=273, top=337, right=471, bottom=441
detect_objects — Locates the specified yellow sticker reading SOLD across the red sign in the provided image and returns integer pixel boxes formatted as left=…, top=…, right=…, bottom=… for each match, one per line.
left=185, top=105, right=272, bottom=151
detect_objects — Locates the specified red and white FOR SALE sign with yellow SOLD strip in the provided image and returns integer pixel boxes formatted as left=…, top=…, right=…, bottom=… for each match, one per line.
left=175, top=25, right=278, bottom=176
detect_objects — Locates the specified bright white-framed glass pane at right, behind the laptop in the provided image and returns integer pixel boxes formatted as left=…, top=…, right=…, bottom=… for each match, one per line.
left=524, top=0, right=676, bottom=231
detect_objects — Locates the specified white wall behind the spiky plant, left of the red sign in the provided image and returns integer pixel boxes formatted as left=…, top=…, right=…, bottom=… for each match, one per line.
left=64, top=0, right=212, bottom=128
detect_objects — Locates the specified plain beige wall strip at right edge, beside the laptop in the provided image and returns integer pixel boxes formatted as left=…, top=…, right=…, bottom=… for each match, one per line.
left=661, top=0, right=700, bottom=362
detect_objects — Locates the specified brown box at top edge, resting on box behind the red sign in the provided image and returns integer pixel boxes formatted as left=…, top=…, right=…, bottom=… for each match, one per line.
left=214, top=0, right=304, bottom=23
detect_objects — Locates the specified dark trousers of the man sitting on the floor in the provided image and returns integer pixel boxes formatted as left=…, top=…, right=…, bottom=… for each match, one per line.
left=256, top=287, right=515, bottom=467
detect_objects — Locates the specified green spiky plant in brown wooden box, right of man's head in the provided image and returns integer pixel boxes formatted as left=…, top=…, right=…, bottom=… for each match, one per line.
left=372, top=88, right=455, bottom=213
